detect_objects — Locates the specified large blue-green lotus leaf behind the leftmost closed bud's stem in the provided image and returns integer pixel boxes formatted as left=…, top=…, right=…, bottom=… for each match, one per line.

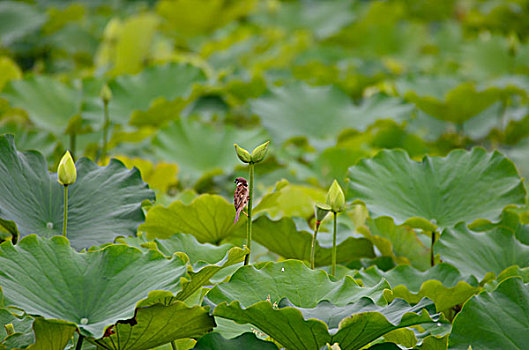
left=0, top=135, right=154, bottom=249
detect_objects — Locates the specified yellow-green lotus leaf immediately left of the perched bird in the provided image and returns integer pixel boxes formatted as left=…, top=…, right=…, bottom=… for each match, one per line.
left=138, top=194, right=241, bottom=244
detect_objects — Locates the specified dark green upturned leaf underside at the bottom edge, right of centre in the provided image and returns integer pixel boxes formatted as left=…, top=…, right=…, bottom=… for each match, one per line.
left=213, top=300, right=331, bottom=350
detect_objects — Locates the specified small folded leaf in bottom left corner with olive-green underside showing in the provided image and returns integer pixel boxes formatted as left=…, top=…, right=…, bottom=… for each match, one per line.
left=0, top=309, right=76, bottom=350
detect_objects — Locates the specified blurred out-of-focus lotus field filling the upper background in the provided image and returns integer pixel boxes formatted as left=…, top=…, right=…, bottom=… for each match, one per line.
left=0, top=0, right=529, bottom=203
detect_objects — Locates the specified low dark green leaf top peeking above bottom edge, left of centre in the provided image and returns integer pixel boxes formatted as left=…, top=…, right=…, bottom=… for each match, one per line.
left=193, top=333, right=277, bottom=350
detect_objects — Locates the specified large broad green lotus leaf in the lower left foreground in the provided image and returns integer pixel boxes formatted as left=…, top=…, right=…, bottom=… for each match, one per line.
left=0, top=235, right=187, bottom=338
